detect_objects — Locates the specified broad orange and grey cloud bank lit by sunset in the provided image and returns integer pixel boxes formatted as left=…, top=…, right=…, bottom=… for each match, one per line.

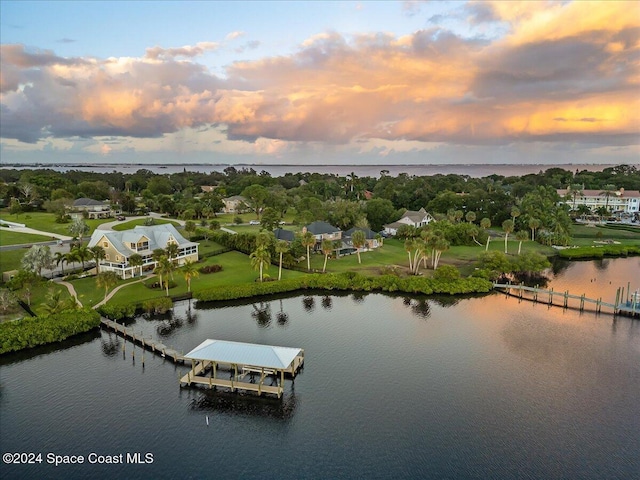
left=0, top=2, right=640, bottom=155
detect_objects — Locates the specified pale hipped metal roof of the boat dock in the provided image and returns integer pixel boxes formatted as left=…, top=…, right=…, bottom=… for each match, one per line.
left=184, top=339, right=302, bottom=369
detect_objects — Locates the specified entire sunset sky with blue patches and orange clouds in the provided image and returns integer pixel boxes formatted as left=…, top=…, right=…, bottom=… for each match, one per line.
left=0, top=0, right=640, bottom=165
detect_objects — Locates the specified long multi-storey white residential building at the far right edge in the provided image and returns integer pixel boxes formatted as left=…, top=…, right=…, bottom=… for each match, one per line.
left=557, top=187, right=640, bottom=215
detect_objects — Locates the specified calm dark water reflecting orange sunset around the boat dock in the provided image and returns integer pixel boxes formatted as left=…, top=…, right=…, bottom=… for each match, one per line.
left=0, top=258, right=640, bottom=479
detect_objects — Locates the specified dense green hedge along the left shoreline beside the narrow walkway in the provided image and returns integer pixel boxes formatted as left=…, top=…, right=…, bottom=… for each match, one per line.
left=0, top=308, right=100, bottom=354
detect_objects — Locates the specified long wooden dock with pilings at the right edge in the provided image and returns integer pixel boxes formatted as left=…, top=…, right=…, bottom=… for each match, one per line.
left=493, top=283, right=640, bottom=317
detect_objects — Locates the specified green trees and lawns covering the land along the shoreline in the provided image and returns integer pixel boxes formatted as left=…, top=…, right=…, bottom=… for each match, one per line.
left=0, top=166, right=640, bottom=354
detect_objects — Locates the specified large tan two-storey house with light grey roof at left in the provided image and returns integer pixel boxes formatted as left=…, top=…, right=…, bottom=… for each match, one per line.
left=89, top=224, right=198, bottom=279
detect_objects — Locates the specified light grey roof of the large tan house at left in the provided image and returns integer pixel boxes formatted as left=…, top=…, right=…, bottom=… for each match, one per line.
left=89, top=223, right=197, bottom=257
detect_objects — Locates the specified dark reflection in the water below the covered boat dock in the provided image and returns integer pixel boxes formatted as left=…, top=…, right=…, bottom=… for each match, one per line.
left=189, top=390, right=297, bottom=420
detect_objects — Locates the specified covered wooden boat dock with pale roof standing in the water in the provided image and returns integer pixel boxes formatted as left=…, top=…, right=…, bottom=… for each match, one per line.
left=180, top=339, right=304, bottom=398
